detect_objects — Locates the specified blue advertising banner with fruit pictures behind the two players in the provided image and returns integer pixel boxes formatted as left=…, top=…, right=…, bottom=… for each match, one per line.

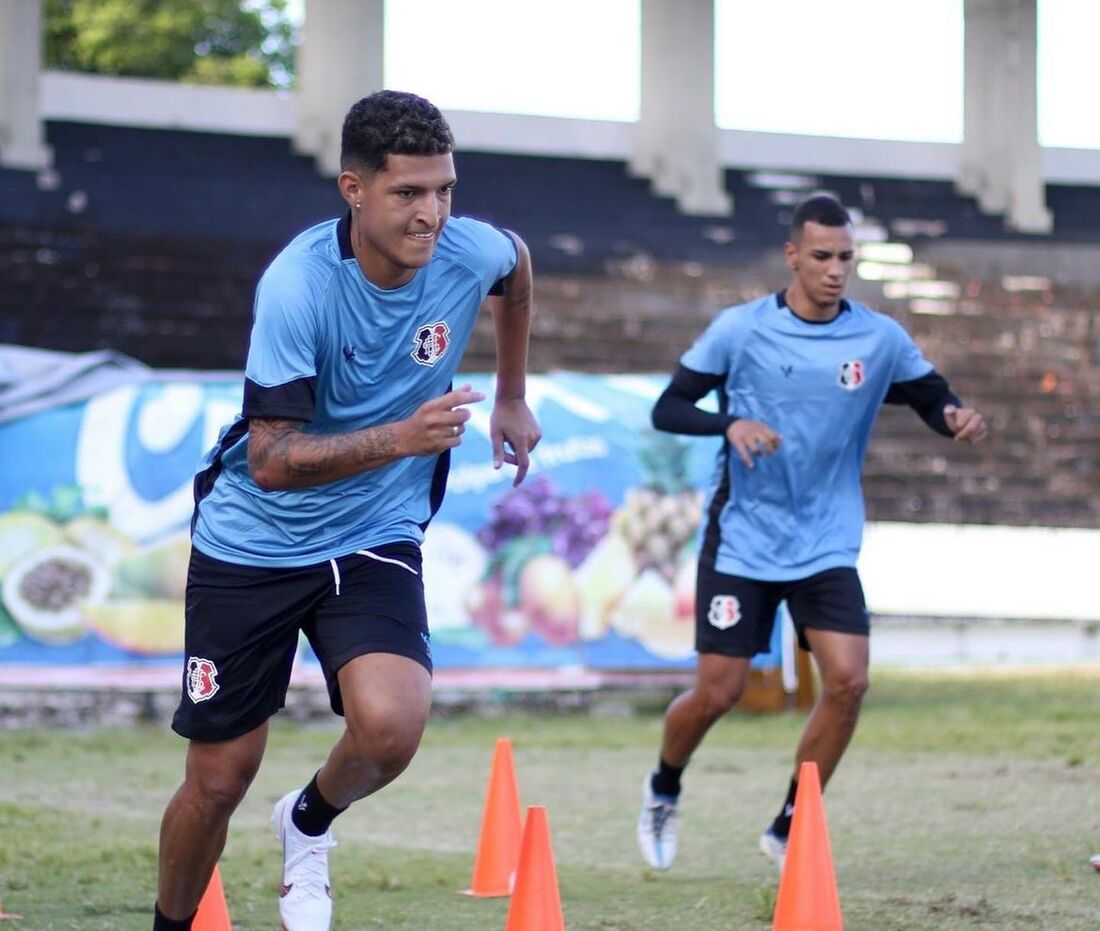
left=0, top=373, right=779, bottom=669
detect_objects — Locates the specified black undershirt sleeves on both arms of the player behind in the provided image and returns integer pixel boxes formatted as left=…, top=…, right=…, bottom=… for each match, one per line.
left=652, top=365, right=963, bottom=437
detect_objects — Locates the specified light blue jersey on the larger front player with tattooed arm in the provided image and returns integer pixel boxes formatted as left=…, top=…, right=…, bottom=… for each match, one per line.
left=193, top=212, right=516, bottom=567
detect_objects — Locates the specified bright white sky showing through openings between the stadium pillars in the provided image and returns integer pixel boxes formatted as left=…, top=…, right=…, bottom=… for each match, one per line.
left=275, top=0, right=1100, bottom=149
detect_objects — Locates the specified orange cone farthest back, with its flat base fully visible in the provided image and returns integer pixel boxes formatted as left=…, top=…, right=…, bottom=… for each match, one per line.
left=463, top=737, right=523, bottom=898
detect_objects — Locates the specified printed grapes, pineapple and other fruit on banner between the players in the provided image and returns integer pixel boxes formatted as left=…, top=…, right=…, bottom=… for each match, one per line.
left=465, top=432, right=702, bottom=659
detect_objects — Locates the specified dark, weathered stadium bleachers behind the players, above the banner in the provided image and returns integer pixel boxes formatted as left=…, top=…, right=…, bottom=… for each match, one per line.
left=0, top=122, right=1100, bottom=527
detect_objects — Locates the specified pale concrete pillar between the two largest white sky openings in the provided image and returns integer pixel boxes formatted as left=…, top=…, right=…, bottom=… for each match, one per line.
left=630, top=0, right=733, bottom=216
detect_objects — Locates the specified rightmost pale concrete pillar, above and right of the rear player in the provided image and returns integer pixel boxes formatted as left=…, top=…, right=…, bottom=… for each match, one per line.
left=956, top=0, right=1053, bottom=233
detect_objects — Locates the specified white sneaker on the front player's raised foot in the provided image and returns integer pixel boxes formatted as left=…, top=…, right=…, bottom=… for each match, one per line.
left=272, top=789, right=337, bottom=931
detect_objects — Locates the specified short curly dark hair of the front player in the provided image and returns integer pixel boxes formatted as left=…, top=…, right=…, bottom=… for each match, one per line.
left=340, top=90, right=454, bottom=174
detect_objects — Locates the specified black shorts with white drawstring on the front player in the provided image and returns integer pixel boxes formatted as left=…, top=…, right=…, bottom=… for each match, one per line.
left=172, top=543, right=431, bottom=741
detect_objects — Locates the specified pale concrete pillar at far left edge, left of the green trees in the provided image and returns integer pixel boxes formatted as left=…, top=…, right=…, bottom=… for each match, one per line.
left=0, top=0, right=51, bottom=171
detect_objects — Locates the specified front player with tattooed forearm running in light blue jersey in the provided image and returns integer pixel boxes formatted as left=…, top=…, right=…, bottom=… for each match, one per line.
left=153, top=91, right=540, bottom=931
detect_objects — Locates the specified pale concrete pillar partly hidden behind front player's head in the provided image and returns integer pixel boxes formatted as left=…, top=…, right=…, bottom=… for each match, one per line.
left=294, top=0, right=385, bottom=176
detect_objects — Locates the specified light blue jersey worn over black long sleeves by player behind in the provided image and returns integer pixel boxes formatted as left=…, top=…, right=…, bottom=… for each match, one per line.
left=680, top=294, right=932, bottom=581
